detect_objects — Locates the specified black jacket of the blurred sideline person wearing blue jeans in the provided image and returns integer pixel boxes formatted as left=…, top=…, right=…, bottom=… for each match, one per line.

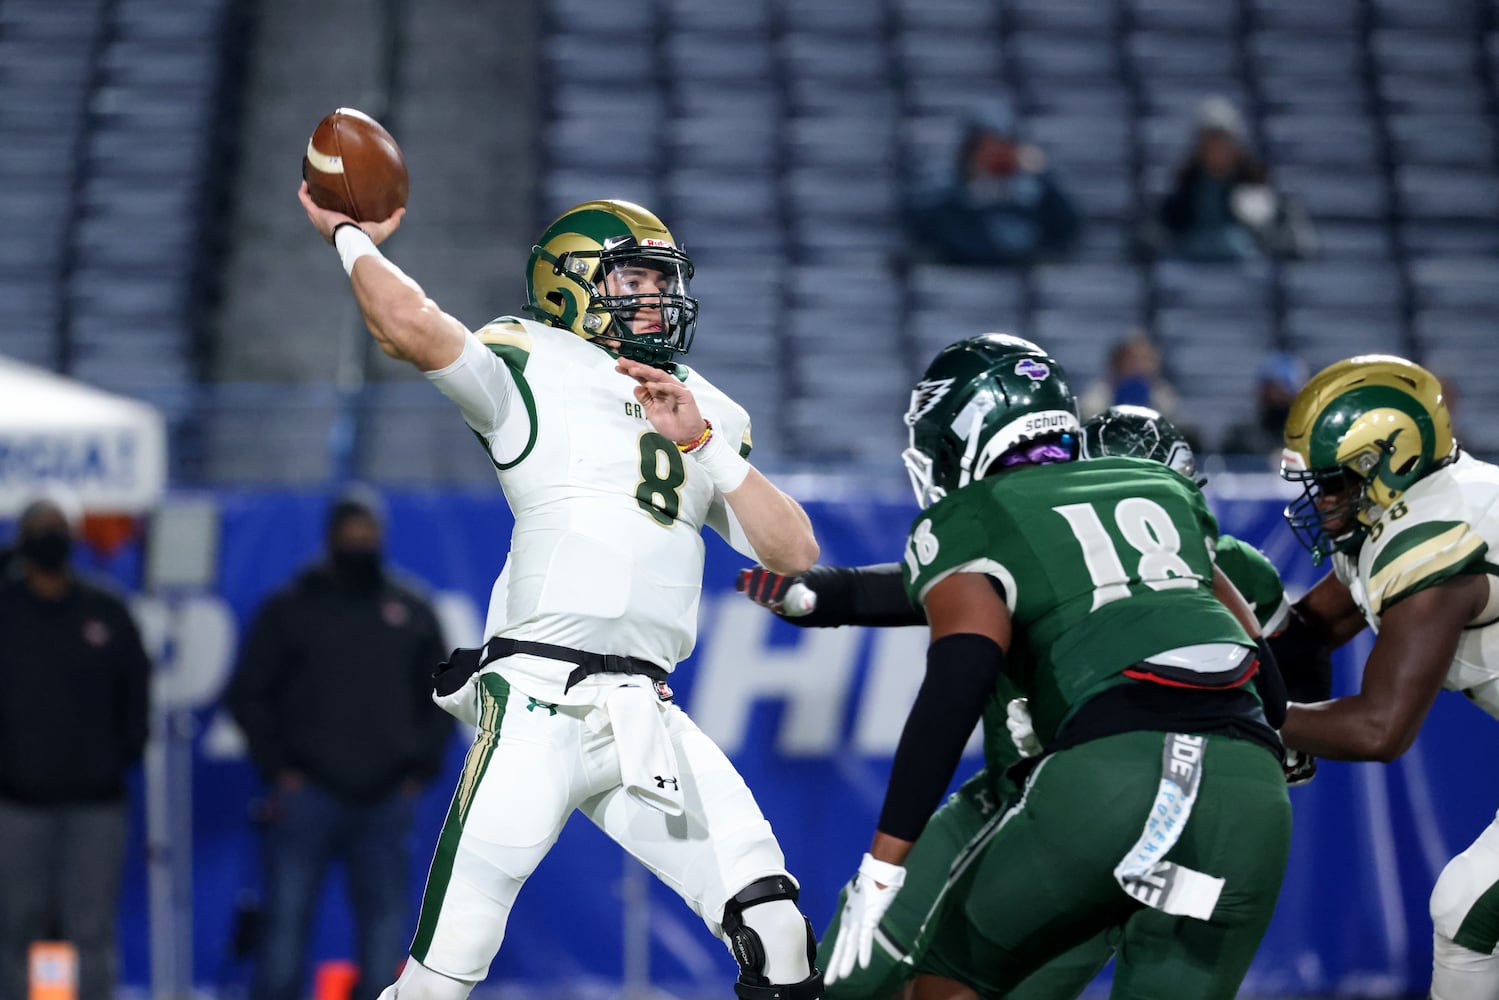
left=225, top=565, right=453, bottom=802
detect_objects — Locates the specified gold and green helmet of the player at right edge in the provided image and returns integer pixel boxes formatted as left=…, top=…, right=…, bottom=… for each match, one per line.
left=1280, top=354, right=1457, bottom=562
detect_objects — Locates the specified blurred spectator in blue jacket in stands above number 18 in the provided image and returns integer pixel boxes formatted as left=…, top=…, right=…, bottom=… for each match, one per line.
left=904, top=102, right=1079, bottom=265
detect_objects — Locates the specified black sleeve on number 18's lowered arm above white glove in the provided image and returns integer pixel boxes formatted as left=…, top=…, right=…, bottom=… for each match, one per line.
left=880, top=633, right=1004, bottom=841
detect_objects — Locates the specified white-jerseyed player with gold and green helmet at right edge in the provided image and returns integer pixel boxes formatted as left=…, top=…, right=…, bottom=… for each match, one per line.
left=1280, top=355, right=1499, bottom=1000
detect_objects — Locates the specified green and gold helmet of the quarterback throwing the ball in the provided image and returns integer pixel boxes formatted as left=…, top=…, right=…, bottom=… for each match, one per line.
left=526, top=201, right=697, bottom=366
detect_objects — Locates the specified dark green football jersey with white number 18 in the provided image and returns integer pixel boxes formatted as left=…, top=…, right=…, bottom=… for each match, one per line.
left=904, top=457, right=1253, bottom=744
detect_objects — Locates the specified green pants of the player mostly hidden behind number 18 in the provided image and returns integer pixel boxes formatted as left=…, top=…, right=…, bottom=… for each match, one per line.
left=817, top=771, right=1114, bottom=1000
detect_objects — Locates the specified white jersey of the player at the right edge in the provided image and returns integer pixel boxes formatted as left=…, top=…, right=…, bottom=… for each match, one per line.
left=1333, top=454, right=1499, bottom=718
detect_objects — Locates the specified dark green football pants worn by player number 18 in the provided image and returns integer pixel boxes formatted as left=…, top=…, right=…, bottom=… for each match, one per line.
left=917, top=732, right=1291, bottom=1000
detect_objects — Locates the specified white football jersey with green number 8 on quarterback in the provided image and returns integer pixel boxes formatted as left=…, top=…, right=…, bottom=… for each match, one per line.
left=427, top=316, right=754, bottom=700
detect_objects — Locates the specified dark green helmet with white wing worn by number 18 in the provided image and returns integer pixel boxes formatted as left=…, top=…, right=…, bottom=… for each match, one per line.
left=901, top=333, right=1078, bottom=507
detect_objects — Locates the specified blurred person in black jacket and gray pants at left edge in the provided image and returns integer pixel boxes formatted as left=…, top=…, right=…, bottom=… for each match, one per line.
left=0, top=499, right=151, bottom=1000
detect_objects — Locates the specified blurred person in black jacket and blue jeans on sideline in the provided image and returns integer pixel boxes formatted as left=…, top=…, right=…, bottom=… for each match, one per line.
left=226, top=498, right=451, bottom=1000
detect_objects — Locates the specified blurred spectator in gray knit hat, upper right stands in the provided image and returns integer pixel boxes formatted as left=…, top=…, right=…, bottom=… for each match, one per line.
left=1147, top=97, right=1312, bottom=261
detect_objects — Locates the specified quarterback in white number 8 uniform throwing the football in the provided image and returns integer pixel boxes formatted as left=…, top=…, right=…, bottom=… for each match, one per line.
left=301, top=186, right=821, bottom=1000
